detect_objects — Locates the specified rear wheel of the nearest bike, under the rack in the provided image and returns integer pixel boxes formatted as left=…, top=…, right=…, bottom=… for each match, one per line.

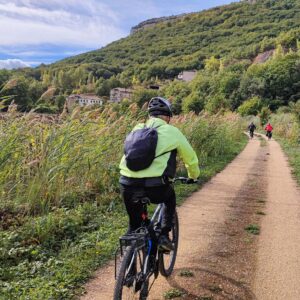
left=113, top=246, right=149, bottom=300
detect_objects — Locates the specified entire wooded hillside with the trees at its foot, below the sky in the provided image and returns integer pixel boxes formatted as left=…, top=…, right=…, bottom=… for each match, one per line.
left=0, top=0, right=300, bottom=115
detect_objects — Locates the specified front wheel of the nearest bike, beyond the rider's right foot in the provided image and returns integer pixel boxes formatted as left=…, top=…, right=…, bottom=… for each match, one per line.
left=158, top=211, right=179, bottom=277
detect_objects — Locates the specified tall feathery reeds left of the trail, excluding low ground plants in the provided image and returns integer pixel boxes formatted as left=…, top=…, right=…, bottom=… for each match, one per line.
left=0, top=106, right=244, bottom=215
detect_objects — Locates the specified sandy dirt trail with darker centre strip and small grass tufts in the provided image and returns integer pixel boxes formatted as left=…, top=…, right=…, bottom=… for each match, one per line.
left=81, top=138, right=300, bottom=300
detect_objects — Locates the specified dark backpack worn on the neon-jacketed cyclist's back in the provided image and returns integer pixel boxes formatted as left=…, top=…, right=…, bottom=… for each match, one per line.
left=124, top=125, right=167, bottom=171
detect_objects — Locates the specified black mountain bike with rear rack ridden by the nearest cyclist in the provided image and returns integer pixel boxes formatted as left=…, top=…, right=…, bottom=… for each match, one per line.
left=113, top=177, right=197, bottom=300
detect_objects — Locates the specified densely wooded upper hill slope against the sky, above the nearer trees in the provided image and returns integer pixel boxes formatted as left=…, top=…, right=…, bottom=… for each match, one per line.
left=53, top=0, right=300, bottom=80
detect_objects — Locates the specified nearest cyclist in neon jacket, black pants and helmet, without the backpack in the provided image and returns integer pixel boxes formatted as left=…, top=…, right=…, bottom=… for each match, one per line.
left=119, top=97, right=200, bottom=251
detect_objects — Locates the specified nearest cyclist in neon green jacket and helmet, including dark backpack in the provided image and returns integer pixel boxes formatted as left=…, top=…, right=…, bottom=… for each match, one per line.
left=120, top=97, right=200, bottom=251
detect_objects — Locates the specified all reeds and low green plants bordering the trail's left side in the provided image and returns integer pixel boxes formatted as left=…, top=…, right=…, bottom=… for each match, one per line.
left=0, top=108, right=246, bottom=300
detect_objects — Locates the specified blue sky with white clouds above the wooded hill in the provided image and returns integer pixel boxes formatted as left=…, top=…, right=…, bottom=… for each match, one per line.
left=0, top=0, right=239, bottom=69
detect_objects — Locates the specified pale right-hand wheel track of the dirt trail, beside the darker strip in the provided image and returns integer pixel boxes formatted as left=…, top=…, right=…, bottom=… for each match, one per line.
left=254, top=141, right=300, bottom=300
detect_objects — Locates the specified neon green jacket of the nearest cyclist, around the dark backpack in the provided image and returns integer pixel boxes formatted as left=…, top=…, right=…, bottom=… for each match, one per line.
left=119, top=118, right=200, bottom=179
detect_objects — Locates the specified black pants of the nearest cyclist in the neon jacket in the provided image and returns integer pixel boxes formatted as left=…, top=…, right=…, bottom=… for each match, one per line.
left=121, top=185, right=176, bottom=234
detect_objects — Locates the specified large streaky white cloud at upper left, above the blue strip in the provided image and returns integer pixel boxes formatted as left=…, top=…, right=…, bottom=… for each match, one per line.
left=0, top=0, right=126, bottom=48
